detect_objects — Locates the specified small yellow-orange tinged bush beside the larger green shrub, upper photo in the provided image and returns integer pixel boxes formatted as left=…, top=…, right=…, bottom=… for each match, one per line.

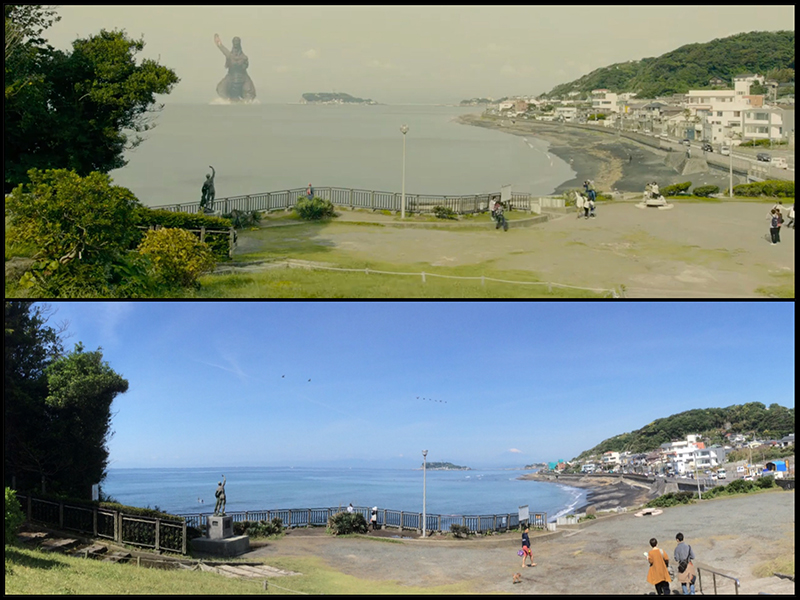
left=139, top=229, right=215, bottom=287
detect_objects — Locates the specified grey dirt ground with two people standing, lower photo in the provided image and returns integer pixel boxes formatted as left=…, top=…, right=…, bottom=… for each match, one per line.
left=248, top=491, right=794, bottom=594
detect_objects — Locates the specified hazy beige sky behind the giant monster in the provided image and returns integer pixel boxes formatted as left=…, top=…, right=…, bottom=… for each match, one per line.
left=45, top=4, right=794, bottom=104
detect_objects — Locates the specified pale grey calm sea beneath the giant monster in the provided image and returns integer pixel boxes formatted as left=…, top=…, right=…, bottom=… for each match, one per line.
left=111, top=104, right=573, bottom=206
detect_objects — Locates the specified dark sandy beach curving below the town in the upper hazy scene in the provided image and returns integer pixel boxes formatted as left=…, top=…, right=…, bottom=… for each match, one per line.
left=456, top=115, right=743, bottom=194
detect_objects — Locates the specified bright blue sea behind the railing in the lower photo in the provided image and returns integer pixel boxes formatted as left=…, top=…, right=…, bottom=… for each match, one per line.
left=103, top=467, right=586, bottom=519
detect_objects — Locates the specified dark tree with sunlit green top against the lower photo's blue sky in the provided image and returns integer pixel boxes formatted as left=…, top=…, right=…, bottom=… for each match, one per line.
left=43, top=343, right=128, bottom=498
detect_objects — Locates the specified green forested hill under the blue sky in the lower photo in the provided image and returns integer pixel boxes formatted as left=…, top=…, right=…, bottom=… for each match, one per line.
left=577, top=402, right=794, bottom=460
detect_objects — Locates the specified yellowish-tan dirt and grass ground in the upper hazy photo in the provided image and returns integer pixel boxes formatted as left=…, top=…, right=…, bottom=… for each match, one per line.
left=237, top=201, right=795, bottom=298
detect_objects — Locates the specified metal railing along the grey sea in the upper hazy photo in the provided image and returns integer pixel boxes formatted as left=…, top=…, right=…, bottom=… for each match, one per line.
left=150, top=187, right=564, bottom=214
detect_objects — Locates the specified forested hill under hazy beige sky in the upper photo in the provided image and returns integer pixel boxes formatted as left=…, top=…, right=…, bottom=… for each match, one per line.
left=542, top=31, right=794, bottom=98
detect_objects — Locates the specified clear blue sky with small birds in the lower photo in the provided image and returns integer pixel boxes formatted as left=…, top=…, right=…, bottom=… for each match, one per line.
left=36, top=302, right=794, bottom=468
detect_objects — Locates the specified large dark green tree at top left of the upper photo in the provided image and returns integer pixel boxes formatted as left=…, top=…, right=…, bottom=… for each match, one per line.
left=4, top=5, right=179, bottom=193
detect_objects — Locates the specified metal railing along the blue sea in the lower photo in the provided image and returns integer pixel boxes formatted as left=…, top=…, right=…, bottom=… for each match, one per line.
left=179, top=507, right=547, bottom=533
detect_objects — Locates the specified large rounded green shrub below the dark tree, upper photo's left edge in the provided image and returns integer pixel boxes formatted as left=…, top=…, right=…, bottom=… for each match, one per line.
left=6, top=169, right=152, bottom=297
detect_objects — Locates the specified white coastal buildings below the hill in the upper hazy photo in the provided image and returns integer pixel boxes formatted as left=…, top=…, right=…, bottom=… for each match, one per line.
left=461, top=73, right=794, bottom=169
